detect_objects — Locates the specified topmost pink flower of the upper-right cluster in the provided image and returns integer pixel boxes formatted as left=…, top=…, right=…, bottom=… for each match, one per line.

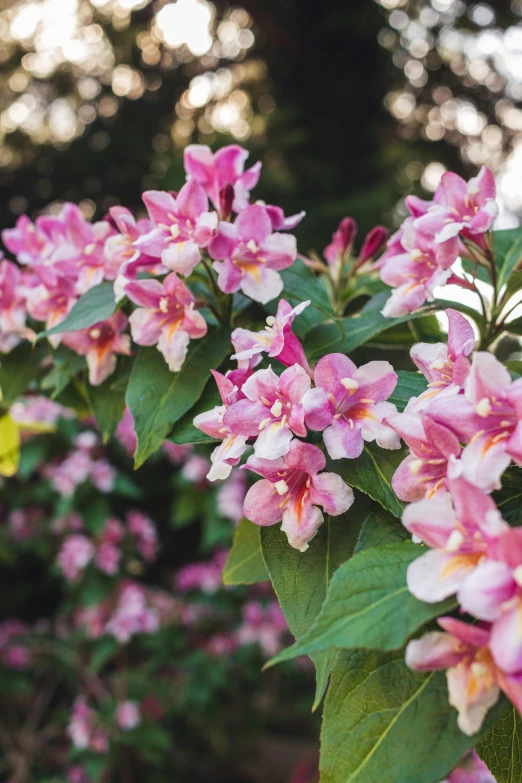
left=416, top=166, right=498, bottom=244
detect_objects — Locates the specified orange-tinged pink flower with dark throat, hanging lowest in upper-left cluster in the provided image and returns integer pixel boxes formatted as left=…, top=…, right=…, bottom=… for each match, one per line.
left=63, top=310, right=130, bottom=386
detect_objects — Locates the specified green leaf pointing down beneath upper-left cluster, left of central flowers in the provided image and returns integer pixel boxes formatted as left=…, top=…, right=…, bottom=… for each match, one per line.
left=126, top=328, right=231, bottom=468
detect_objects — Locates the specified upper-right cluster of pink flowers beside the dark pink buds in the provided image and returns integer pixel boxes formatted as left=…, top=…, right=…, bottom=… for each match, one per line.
left=378, top=167, right=498, bottom=317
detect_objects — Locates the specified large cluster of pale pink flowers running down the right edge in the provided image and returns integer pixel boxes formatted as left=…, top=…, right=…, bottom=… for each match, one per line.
left=376, top=310, right=522, bottom=735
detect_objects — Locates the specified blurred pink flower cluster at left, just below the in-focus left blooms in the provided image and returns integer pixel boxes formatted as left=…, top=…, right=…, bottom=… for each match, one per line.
left=41, top=430, right=116, bottom=497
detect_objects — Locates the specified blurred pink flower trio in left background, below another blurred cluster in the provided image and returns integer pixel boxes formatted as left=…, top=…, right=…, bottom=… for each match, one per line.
left=57, top=510, right=158, bottom=582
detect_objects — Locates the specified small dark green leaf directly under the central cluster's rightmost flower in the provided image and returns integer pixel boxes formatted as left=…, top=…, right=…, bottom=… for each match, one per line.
left=332, top=443, right=406, bottom=517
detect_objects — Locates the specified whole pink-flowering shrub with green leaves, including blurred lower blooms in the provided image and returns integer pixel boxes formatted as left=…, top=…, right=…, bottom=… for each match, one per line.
left=0, top=146, right=522, bottom=783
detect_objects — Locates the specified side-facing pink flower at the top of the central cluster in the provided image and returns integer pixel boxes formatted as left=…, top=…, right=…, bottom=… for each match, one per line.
left=232, top=299, right=312, bottom=375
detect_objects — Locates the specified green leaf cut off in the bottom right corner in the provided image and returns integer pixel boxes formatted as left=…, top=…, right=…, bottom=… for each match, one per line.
left=477, top=704, right=522, bottom=783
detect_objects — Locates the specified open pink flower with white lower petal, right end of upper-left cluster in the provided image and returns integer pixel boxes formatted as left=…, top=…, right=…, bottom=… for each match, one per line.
left=208, top=204, right=297, bottom=304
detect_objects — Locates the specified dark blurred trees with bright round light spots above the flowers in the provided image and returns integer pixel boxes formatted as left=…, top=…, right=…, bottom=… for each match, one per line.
left=0, top=0, right=522, bottom=252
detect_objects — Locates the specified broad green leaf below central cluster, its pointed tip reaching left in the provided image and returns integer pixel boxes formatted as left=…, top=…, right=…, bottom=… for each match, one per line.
left=271, top=541, right=457, bottom=663
